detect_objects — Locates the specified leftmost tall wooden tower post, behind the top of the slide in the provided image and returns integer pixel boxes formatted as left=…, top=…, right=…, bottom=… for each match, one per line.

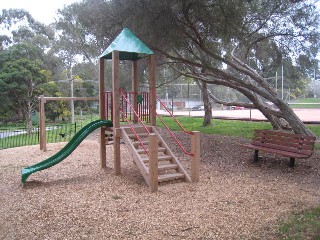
left=99, top=58, right=107, bottom=168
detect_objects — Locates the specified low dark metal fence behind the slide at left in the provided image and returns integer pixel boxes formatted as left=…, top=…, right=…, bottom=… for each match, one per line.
left=0, top=123, right=79, bottom=149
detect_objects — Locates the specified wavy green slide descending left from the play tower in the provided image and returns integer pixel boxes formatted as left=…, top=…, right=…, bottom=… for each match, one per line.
left=21, top=120, right=112, bottom=183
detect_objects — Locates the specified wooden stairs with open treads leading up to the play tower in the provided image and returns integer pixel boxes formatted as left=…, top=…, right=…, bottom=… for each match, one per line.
left=121, top=125, right=191, bottom=189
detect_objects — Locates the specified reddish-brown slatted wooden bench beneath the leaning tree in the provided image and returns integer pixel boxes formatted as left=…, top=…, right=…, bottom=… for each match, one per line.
left=241, top=130, right=316, bottom=167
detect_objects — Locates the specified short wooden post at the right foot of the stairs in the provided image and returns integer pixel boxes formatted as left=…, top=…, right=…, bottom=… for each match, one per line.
left=191, top=131, right=200, bottom=182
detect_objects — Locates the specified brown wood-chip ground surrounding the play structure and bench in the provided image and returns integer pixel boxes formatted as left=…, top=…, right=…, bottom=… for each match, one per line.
left=0, top=133, right=320, bottom=239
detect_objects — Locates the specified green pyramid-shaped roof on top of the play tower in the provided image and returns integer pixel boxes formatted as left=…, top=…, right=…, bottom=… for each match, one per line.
left=100, top=28, right=154, bottom=60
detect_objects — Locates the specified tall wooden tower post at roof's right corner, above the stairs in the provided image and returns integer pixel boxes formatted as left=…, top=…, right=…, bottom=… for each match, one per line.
left=149, top=55, right=157, bottom=126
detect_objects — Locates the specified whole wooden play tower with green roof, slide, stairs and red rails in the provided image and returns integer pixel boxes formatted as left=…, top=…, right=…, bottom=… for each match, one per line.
left=22, top=28, right=200, bottom=192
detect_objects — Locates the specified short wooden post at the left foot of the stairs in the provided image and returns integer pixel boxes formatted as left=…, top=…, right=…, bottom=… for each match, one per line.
left=149, top=133, right=158, bottom=192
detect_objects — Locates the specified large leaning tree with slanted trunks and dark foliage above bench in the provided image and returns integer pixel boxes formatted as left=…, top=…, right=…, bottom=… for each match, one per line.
left=85, top=0, right=319, bottom=135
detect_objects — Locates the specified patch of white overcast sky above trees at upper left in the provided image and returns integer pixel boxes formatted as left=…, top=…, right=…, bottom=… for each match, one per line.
left=0, top=0, right=80, bottom=24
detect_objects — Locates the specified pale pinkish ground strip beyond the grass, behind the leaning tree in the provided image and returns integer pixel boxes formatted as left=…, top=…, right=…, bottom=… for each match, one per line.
left=157, top=109, right=320, bottom=123
